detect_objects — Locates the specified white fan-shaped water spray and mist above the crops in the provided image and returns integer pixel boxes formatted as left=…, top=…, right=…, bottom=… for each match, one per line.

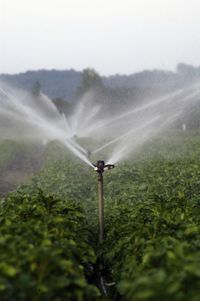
left=0, top=77, right=200, bottom=167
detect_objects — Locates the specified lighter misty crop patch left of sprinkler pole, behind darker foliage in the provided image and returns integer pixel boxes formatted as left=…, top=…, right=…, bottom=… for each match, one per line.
left=22, top=155, right=101, bottom=248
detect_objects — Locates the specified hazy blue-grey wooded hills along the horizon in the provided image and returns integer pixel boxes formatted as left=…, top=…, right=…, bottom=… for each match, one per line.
left=0, top=63, right=200, bottom=102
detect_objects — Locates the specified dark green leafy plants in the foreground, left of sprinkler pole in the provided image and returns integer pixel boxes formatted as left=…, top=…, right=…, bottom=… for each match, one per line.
left=0, top=190, right=99, bottom=301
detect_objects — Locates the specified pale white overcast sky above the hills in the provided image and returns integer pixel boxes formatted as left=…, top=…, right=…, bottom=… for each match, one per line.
left=0, top=0, right=200, bottom=75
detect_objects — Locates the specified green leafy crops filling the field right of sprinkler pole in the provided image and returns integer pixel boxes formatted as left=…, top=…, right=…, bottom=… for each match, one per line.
left=102, top=154, right=200, bottom=301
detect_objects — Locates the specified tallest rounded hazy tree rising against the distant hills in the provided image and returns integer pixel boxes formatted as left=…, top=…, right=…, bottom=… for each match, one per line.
left=77, top=68, right=103, bottom=96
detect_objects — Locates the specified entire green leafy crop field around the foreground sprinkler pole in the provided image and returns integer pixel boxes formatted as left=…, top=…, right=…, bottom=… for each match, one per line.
left=0, top=132, right=200, bottom=301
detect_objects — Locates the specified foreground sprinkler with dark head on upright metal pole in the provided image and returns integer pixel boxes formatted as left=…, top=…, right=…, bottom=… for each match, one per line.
left=94, top=160, right=115, bottom=244
